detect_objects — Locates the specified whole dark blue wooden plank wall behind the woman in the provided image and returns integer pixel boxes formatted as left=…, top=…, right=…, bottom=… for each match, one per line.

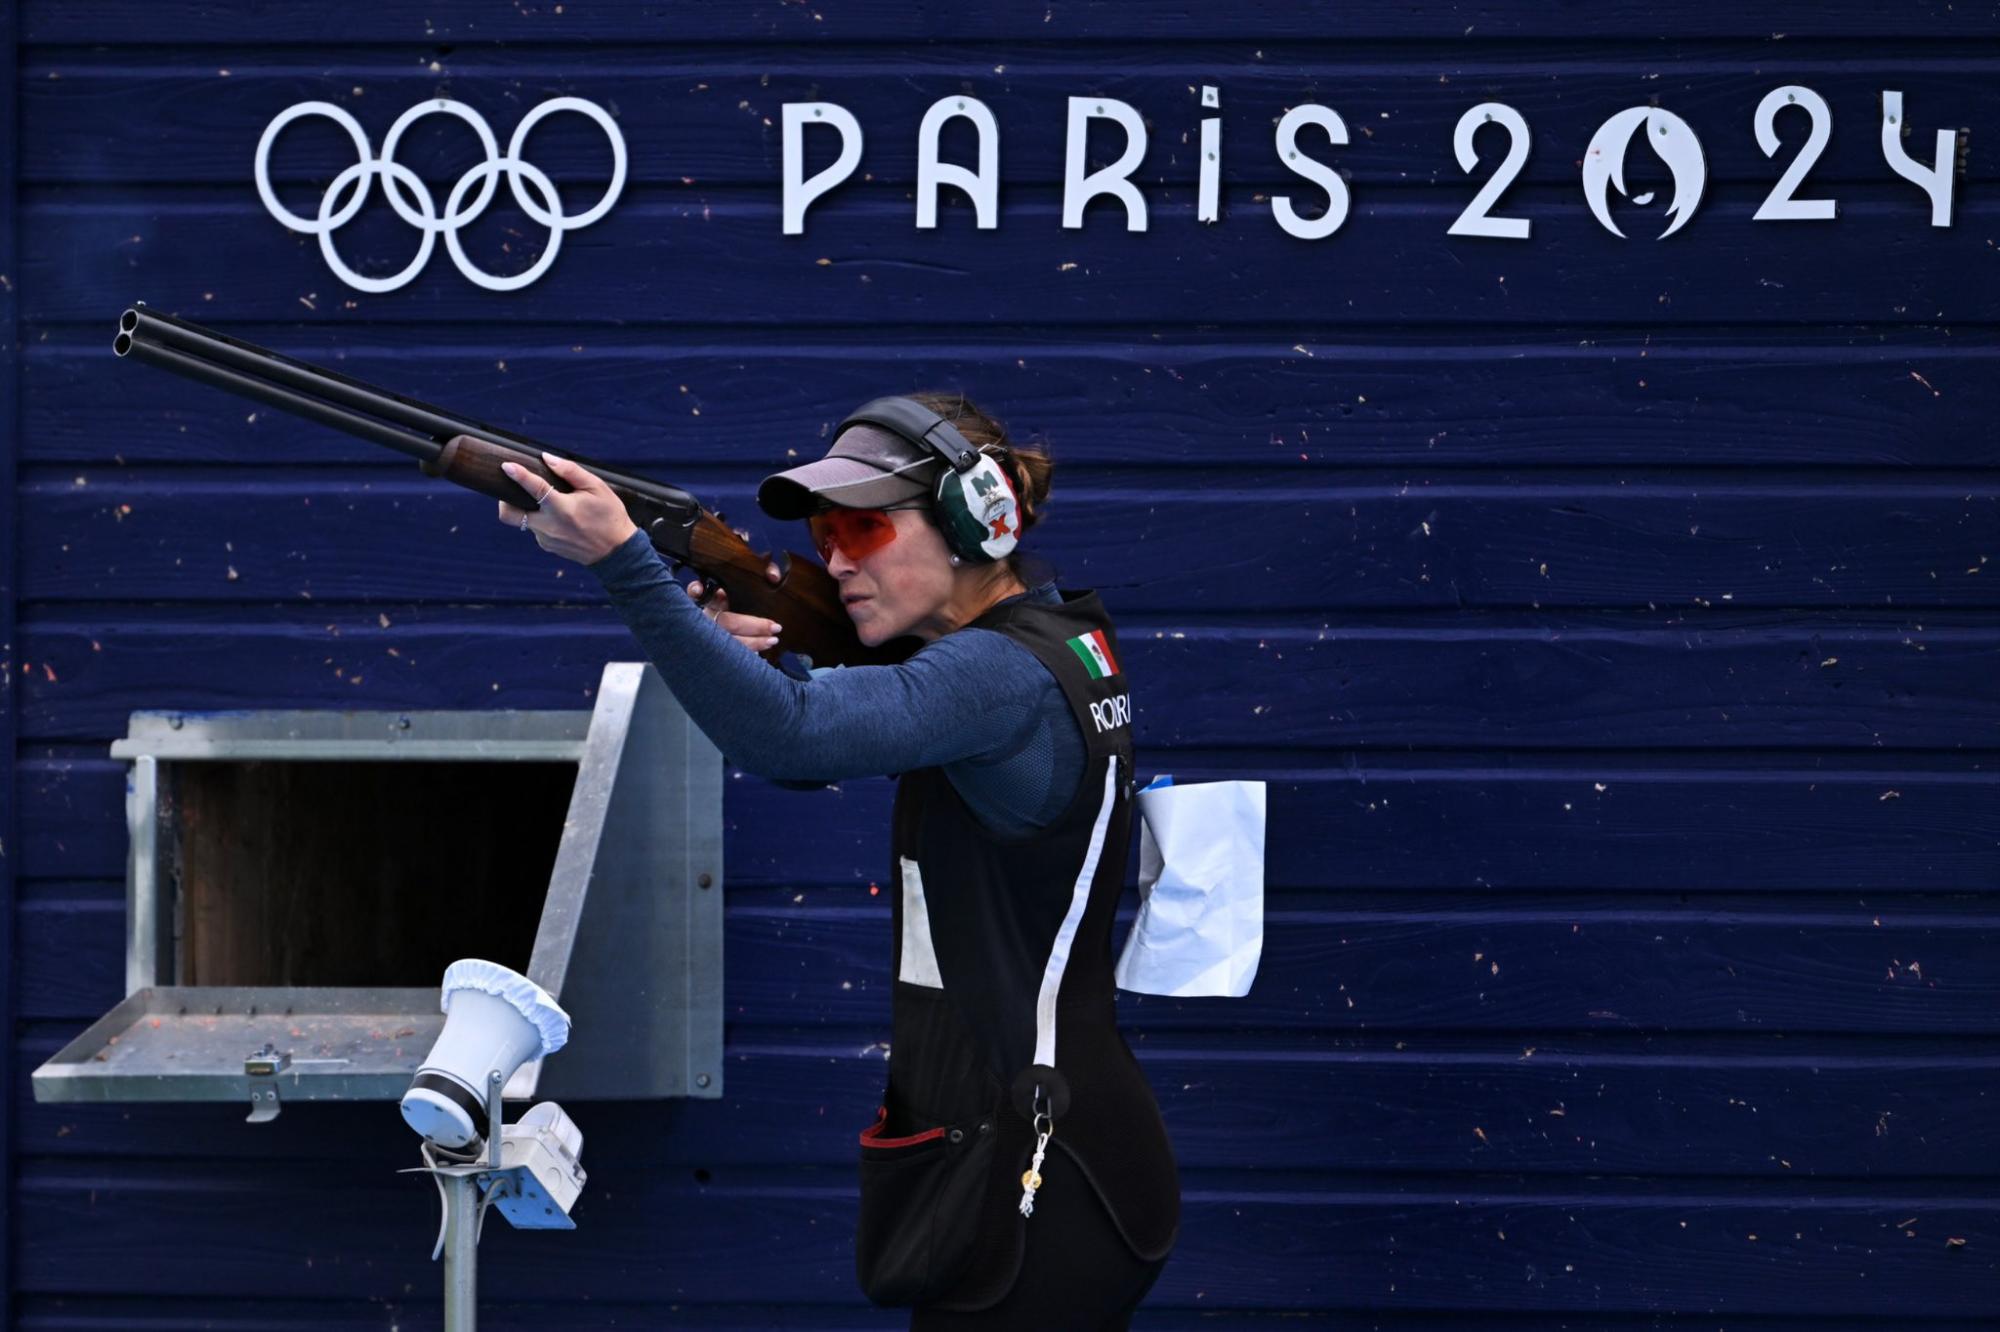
left=0, top=0, right=2000, bottom=1332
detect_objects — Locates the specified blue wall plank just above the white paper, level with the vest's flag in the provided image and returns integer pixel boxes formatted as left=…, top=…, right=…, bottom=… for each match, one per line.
left=18, top=612, right=2000, bottom=748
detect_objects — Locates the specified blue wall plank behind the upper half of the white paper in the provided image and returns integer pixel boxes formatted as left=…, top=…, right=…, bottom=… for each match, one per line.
left=16, top=740, right=2000, bottom=902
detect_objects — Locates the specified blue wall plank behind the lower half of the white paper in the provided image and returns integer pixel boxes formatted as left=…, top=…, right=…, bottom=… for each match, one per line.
left=18, top=888, right=2000, bottom=1036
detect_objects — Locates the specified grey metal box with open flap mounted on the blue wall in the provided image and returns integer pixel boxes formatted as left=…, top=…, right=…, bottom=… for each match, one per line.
left=34, top=662, right=722, bottom=1120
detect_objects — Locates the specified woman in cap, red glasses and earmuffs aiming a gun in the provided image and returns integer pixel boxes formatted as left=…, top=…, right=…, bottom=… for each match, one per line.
left=500, top=394, right=1180, bottom=1332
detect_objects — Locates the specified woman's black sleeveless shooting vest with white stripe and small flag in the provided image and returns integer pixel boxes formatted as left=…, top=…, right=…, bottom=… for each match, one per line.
left=878, top=592, right=1180, bottom=1308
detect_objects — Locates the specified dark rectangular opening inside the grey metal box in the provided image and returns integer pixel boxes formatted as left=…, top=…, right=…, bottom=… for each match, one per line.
left=160, top=760, right=576, bottom=986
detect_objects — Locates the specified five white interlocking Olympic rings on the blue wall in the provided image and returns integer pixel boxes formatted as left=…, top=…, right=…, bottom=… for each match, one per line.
left=256, top=98, right=626, bottom=292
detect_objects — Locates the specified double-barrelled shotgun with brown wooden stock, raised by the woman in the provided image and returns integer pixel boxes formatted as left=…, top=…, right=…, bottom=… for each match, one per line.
left=112, top=302, right=918, bottom=666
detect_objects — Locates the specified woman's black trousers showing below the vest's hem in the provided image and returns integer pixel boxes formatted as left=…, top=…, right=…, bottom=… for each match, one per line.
left=910, top=1152, right=1166, bottom=1332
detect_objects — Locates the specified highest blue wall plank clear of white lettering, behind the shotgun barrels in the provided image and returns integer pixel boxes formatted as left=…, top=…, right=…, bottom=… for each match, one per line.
left=20, top=332, right=2000, bottom=472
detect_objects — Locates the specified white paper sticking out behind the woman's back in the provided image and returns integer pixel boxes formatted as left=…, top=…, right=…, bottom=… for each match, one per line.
left=1114, top=778, right=1264, bottom=998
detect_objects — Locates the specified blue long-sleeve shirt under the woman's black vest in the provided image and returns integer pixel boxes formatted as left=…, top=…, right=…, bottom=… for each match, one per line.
left=588, top=532, right=1084, bottom=836
